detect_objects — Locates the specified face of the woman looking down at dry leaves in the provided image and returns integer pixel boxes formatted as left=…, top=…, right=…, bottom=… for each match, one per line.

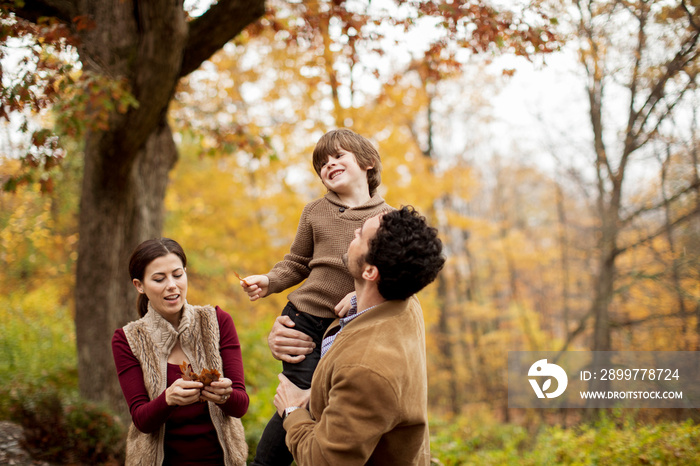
left=133, top=253, right=187, bottom=328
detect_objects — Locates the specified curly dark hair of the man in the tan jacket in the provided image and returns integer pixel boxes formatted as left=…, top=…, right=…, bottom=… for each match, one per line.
left=365, top=206, right=445, bottom=300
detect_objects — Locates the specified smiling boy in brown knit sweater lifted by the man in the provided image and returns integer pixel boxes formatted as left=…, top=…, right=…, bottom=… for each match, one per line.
left=241, top=129, right=392, bottom=465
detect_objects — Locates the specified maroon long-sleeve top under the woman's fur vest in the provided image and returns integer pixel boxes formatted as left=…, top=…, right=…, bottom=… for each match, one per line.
left=112, top=306, right=249, bottom=464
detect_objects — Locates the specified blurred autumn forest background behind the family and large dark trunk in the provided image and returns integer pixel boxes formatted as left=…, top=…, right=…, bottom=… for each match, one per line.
left=0, top=0, right=700, bottom=464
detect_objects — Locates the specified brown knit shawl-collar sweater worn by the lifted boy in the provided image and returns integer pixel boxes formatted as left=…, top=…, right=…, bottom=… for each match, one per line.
left=267, top=191, right=392, bottom=318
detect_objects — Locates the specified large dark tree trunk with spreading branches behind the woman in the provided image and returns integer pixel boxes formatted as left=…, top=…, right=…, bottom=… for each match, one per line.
left=41, top=0, right=264, bottom=419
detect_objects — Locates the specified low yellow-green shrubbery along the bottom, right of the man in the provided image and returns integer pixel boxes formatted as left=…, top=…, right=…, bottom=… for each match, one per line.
left=431, top=413, right=700, bottom=466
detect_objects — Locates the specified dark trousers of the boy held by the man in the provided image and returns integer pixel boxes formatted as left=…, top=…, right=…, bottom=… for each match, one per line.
left=250, top=303, right=335, bottom=466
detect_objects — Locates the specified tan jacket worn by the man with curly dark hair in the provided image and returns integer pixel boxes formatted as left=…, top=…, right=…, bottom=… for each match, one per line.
left=284, top=296, right=430, bottom=466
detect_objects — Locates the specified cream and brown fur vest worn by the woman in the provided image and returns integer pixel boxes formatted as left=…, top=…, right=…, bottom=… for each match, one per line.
left=124, top=303, right=248, bottom=466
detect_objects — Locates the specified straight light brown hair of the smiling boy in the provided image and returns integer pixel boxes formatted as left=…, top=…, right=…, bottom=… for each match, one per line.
left=312, top=128, right=382, bottom=196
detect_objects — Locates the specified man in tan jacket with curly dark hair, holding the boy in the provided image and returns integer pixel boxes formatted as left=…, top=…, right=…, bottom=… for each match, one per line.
left=275, top=207, right=445, bottom=466
